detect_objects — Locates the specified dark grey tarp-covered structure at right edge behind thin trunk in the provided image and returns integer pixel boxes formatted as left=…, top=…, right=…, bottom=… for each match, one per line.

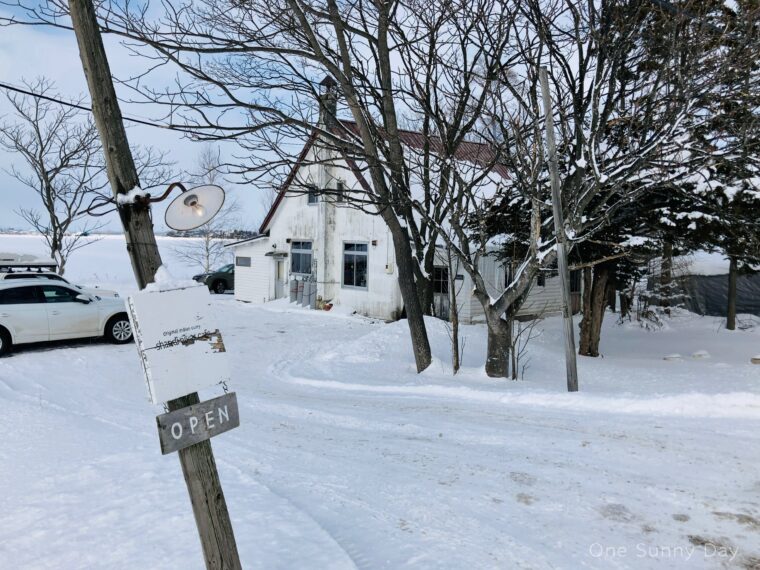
left=682, top=273, right=760, bottom=317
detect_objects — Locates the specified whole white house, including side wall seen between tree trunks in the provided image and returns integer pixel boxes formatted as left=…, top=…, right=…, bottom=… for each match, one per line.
left=227, top=89, right=576, bottom=322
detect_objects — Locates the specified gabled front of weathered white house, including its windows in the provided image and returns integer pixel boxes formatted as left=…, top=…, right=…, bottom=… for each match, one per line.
left=227, top=125, right=402, bottom=320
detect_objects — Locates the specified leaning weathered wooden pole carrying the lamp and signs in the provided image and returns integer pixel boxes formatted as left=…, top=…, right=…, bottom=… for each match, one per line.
left=69, top=0, right=241, bottom=570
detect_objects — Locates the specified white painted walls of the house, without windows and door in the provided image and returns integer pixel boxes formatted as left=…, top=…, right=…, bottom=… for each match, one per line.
left=232, top=143, right=561, bottom=323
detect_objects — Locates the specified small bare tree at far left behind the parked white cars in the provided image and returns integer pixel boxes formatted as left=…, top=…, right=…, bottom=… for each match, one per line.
left=0, top=79, right=107, bottom=275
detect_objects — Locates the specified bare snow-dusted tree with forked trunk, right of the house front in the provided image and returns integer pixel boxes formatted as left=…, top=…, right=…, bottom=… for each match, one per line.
left=410, top=0, right=724, bottom=376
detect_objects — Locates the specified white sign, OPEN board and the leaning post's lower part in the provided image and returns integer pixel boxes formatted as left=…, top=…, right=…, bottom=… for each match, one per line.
left=127, top=285, right=242, bottom=570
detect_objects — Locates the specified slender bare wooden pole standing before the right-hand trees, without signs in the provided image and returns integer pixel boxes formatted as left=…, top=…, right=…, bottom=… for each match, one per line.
left=538, top=67, right=578, bottom=392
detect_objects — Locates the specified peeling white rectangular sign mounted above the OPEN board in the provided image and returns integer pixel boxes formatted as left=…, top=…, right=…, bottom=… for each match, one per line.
left=127, top=285, right=230, bottom=404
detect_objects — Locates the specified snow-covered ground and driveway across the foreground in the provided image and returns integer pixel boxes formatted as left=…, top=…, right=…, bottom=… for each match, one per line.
left=0, top=233, right=760, bottom=569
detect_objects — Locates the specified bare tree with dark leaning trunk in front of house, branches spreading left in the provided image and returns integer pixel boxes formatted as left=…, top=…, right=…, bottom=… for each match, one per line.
left=0, top=0, right=443, bottom=371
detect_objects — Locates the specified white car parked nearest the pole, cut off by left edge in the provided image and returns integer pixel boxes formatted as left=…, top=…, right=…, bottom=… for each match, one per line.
left=0, top=279, right=132, bottom=355
